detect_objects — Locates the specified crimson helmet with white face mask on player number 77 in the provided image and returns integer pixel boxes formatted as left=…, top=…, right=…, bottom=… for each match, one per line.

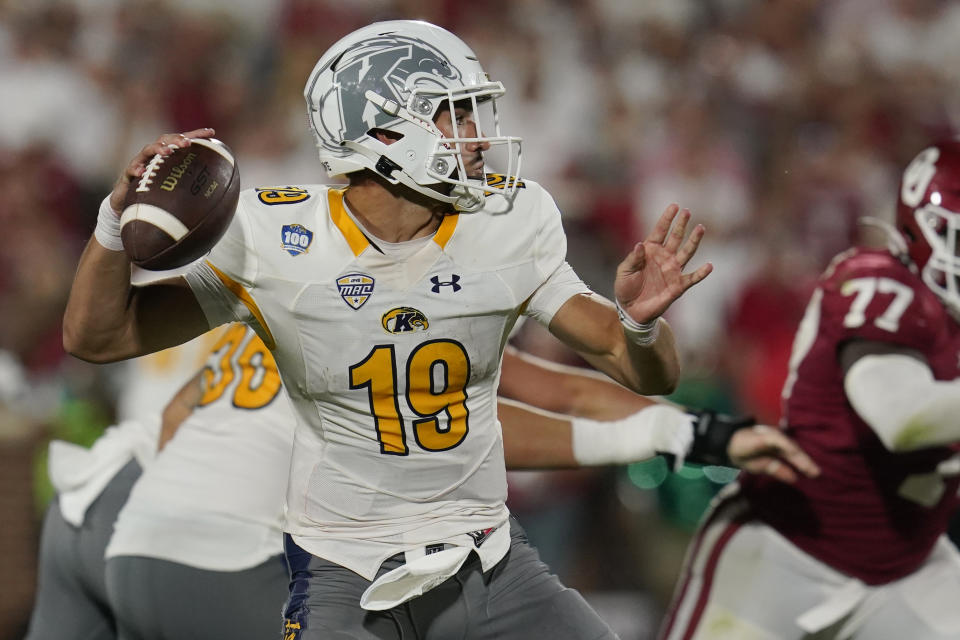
left=896, top=138, right=960, bottom=315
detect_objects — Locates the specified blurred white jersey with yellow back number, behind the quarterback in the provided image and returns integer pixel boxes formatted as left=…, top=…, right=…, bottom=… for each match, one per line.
left=106, top=324, right=296, bottom=571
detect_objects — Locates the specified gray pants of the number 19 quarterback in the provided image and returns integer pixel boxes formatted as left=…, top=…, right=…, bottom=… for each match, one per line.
left=283, top=519, right=616, bottom=640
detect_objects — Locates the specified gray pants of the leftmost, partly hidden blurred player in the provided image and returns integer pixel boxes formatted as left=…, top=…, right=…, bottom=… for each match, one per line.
left=25, top=461, right=140, bottom=640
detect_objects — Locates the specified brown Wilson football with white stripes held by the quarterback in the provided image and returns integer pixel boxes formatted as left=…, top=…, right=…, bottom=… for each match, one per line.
left=120, top=138, right=240, bottom=271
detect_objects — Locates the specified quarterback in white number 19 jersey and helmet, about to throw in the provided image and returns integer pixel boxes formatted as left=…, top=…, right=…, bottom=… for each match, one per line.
left=64, top=21, right=744, bottom=638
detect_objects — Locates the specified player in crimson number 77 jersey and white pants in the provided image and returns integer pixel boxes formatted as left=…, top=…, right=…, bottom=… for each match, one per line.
left=661, top=139, right=960, bottom=640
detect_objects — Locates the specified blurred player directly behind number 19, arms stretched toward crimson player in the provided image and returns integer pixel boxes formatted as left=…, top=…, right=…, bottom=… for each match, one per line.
left=101, top=325, right=804, bottom=640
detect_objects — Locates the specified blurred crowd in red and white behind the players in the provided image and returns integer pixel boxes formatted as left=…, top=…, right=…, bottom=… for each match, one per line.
left=0, top=0, right=960, bottom=640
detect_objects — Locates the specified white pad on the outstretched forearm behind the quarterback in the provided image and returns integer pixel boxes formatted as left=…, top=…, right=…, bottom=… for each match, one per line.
left=571, top=404, right=693, bottom=468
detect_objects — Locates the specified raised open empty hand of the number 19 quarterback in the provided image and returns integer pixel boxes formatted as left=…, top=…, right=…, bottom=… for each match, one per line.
left=613, top=204, right=713, bottom=322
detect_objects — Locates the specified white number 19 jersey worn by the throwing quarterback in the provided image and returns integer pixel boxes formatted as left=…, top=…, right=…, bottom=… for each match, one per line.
left=186, top=182, right=588, bottom=579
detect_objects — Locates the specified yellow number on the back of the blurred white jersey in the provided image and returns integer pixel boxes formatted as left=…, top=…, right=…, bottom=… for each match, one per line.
left=199, top=324, right=280, bottom=409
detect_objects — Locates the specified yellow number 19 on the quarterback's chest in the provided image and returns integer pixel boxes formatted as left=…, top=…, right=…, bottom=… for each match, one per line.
left=350, top=340, right=470, bottom=456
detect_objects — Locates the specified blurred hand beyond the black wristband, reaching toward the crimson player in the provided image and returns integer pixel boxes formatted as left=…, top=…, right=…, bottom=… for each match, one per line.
left=727, top=424, right=820, bottom=483
